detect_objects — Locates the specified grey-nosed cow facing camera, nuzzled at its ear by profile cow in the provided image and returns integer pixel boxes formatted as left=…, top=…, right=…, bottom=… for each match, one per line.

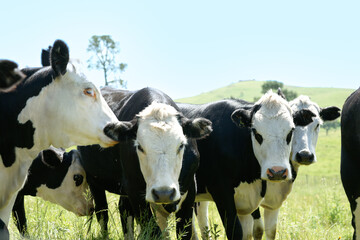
left=78, top=88, right=211, bottom=238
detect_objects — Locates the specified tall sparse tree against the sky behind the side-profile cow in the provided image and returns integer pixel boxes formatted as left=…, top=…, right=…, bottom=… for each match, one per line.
left=87, top=35, right=127, bottom=88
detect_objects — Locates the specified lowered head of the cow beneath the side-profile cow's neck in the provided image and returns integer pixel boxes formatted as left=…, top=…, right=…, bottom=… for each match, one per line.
left=36, top=148, right=94, bottom=216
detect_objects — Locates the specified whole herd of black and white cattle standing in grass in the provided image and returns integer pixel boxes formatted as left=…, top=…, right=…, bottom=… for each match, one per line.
left=0, top=40, right=360, bottom=239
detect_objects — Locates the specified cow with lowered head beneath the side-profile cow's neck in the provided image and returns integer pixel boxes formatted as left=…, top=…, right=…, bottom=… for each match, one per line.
left=12, top=147, right=94, bottom=235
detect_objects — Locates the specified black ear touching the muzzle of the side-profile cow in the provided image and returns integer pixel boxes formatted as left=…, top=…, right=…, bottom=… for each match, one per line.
left=104, top=117, right=138, bottom=142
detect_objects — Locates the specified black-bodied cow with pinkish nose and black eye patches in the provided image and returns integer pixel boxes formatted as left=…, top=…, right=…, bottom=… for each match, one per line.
left=178, top=92, right=314, bottom=239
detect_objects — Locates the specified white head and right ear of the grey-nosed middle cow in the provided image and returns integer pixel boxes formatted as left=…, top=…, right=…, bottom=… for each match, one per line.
left=105, top=102, right=212, bottom=204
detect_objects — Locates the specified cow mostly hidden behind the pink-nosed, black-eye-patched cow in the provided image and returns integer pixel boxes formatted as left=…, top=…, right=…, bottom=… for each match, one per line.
left=197, top=92, right=340, bottom=239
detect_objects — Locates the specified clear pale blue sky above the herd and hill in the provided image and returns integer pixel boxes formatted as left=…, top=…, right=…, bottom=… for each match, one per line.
left=0, top=0, right=360, bottom=99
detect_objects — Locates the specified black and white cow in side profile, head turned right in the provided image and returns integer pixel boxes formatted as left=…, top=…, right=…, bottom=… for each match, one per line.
left=0, top=40, right=131, bottom=238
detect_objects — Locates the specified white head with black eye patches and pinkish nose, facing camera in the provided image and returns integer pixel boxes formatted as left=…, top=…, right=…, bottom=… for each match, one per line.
left=231, top=91, right=313, bottom=181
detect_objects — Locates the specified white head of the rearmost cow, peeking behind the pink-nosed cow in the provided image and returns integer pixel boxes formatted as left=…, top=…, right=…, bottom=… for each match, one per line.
left=289, top=95, right=340, bottom=165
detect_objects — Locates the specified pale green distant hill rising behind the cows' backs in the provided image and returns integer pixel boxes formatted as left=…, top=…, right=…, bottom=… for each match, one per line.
left=177, top=81, right=355, bottom=108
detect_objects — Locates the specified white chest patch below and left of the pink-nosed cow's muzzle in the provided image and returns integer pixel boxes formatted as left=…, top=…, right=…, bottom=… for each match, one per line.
left=234, top=179, right=263, bottom=215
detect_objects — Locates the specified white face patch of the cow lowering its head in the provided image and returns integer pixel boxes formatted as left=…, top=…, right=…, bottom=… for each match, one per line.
left=36, top=150, right=94, bottom=216
